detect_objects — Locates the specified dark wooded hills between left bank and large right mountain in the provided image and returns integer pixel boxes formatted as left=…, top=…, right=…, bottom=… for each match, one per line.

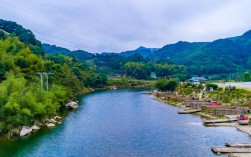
left=43, top=44, right=186, bottom=80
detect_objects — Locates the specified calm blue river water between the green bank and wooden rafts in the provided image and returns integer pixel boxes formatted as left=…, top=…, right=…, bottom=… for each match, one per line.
left=0, top=90, right=251, bottom=157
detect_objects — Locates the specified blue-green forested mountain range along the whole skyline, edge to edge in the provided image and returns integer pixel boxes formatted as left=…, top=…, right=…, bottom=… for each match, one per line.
left=0, top=19, right=251, bottom=75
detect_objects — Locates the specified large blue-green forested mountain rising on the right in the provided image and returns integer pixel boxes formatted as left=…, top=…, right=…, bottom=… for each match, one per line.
left=148, top=31, right=251, bottom=75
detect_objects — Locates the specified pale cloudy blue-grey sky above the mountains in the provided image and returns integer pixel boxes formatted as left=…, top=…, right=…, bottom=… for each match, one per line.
left=0, top=0, right=251, bottom=52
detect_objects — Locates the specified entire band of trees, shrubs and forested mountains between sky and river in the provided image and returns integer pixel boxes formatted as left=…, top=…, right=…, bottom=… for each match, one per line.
left=0, top=17, right=251, bottom=137
